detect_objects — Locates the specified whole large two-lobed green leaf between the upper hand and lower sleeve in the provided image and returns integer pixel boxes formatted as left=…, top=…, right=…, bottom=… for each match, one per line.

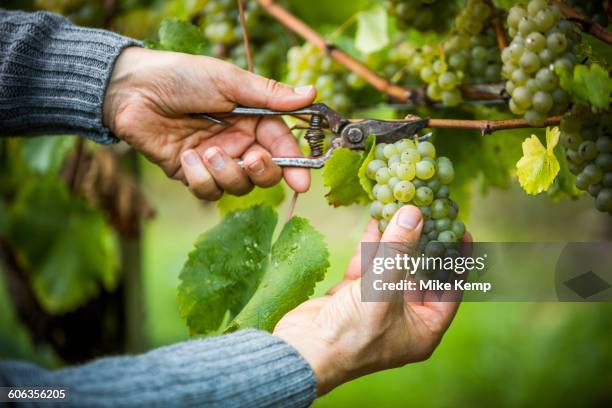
left=177, top=205, right=329, bottom=334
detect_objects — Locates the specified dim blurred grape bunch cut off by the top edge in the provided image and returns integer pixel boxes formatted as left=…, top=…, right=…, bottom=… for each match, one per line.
left=385, top=0, right=457, bottom=32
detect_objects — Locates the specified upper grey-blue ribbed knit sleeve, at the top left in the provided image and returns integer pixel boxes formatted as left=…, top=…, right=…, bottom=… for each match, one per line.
left=0, top=9, right=139, bottom=143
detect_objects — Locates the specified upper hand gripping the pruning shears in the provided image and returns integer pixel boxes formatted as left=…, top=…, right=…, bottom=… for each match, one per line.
left=103, top=47, right=316, bottom=200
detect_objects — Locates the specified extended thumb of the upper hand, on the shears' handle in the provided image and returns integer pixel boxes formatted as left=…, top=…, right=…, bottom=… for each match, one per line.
left=226, top=68, right=317, bottom=111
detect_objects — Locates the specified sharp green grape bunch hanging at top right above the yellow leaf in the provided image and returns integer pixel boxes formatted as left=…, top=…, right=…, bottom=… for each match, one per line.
left=502, top=0, right=579, bottom=126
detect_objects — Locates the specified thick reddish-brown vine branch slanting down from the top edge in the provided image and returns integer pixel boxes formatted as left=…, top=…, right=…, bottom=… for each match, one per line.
left=259, top=0, right=502, bottom=105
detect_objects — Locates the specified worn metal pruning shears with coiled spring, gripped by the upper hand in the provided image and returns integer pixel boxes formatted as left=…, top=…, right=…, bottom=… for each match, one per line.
left=197, top=103, right=431, bottom=169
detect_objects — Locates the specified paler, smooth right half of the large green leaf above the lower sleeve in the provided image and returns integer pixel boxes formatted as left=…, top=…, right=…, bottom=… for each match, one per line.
left=228, top=217, right=329, bottom=331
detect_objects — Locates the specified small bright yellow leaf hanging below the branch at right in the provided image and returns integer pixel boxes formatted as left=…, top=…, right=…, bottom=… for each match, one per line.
left=516, top=127, right=560, bottom=195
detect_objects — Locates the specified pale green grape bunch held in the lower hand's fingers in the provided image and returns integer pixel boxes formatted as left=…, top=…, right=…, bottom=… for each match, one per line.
left=366, top=139, right=465, bottom=247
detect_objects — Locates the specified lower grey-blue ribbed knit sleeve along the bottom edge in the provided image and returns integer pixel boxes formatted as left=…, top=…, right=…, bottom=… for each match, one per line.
left=0, top=330, right=316, bottom=408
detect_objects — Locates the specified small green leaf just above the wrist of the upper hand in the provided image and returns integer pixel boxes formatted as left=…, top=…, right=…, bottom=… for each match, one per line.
left=159, top=18, right=204, bottom=54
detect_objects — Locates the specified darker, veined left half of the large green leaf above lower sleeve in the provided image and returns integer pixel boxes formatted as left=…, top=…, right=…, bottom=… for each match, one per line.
left=177, top=205, right=277, bottom=334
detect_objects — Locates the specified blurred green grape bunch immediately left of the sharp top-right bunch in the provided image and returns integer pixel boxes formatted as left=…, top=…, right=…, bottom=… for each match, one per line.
left=409, top=0, right=501, bottom=106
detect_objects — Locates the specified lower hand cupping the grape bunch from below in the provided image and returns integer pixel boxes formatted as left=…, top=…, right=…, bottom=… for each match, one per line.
left=274, top=206, right=471, bottom=395
